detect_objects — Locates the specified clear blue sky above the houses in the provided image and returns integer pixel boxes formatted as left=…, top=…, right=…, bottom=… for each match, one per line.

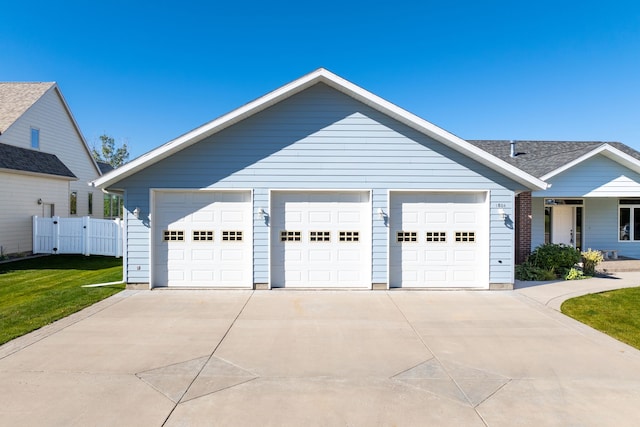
left=0, top=0, right=640, bottom=158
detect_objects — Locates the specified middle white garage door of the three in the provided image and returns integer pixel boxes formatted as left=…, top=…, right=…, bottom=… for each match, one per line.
left=271, top=192, right=371, bottom=288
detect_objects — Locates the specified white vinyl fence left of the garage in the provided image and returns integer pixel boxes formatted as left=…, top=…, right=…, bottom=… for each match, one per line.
left=33, top=216, right=122, bottom=257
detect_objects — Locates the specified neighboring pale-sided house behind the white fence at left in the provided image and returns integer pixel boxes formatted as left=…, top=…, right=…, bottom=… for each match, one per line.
left=0, top=83, right=103, bottom=254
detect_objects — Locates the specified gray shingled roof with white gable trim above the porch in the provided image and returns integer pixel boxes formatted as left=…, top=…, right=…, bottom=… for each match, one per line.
left=468, top=140, right=640, bottom=180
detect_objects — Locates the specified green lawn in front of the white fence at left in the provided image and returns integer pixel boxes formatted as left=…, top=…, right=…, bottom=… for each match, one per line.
left=0, top=255, right=124, bottom=344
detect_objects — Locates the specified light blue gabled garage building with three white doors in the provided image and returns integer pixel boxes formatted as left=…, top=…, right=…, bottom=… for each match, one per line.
left=95, top=69, right=546, bottom=289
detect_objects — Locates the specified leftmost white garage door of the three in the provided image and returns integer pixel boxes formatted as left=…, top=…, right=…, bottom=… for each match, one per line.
left=152, top=191, right=253, bottom=287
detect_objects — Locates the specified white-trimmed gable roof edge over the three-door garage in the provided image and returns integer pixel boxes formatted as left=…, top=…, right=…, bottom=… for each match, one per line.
left=94, top=68, right=547, bottom=190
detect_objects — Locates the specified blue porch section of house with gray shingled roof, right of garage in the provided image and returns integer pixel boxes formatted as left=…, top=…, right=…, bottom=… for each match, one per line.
left=469, top=141, right=640, bottom=262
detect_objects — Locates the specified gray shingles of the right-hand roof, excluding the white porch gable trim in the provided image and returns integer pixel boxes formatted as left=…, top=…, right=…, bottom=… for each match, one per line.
left=467, top=140, right=640, bottom=178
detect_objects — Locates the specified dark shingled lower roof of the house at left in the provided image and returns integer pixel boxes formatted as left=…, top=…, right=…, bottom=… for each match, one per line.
left=0, top=143, right=77, bottom=179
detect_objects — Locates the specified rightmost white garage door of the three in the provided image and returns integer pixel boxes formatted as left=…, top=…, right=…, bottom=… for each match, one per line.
left=389, top=193, right=489, bottom=288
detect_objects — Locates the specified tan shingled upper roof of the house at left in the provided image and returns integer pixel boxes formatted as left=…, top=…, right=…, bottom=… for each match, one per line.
left=0, top=82, right=55, bottom=134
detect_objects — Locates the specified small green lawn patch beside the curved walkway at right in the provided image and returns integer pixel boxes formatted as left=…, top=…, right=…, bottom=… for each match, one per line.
left=560, top=287, right=640, bottom=349
